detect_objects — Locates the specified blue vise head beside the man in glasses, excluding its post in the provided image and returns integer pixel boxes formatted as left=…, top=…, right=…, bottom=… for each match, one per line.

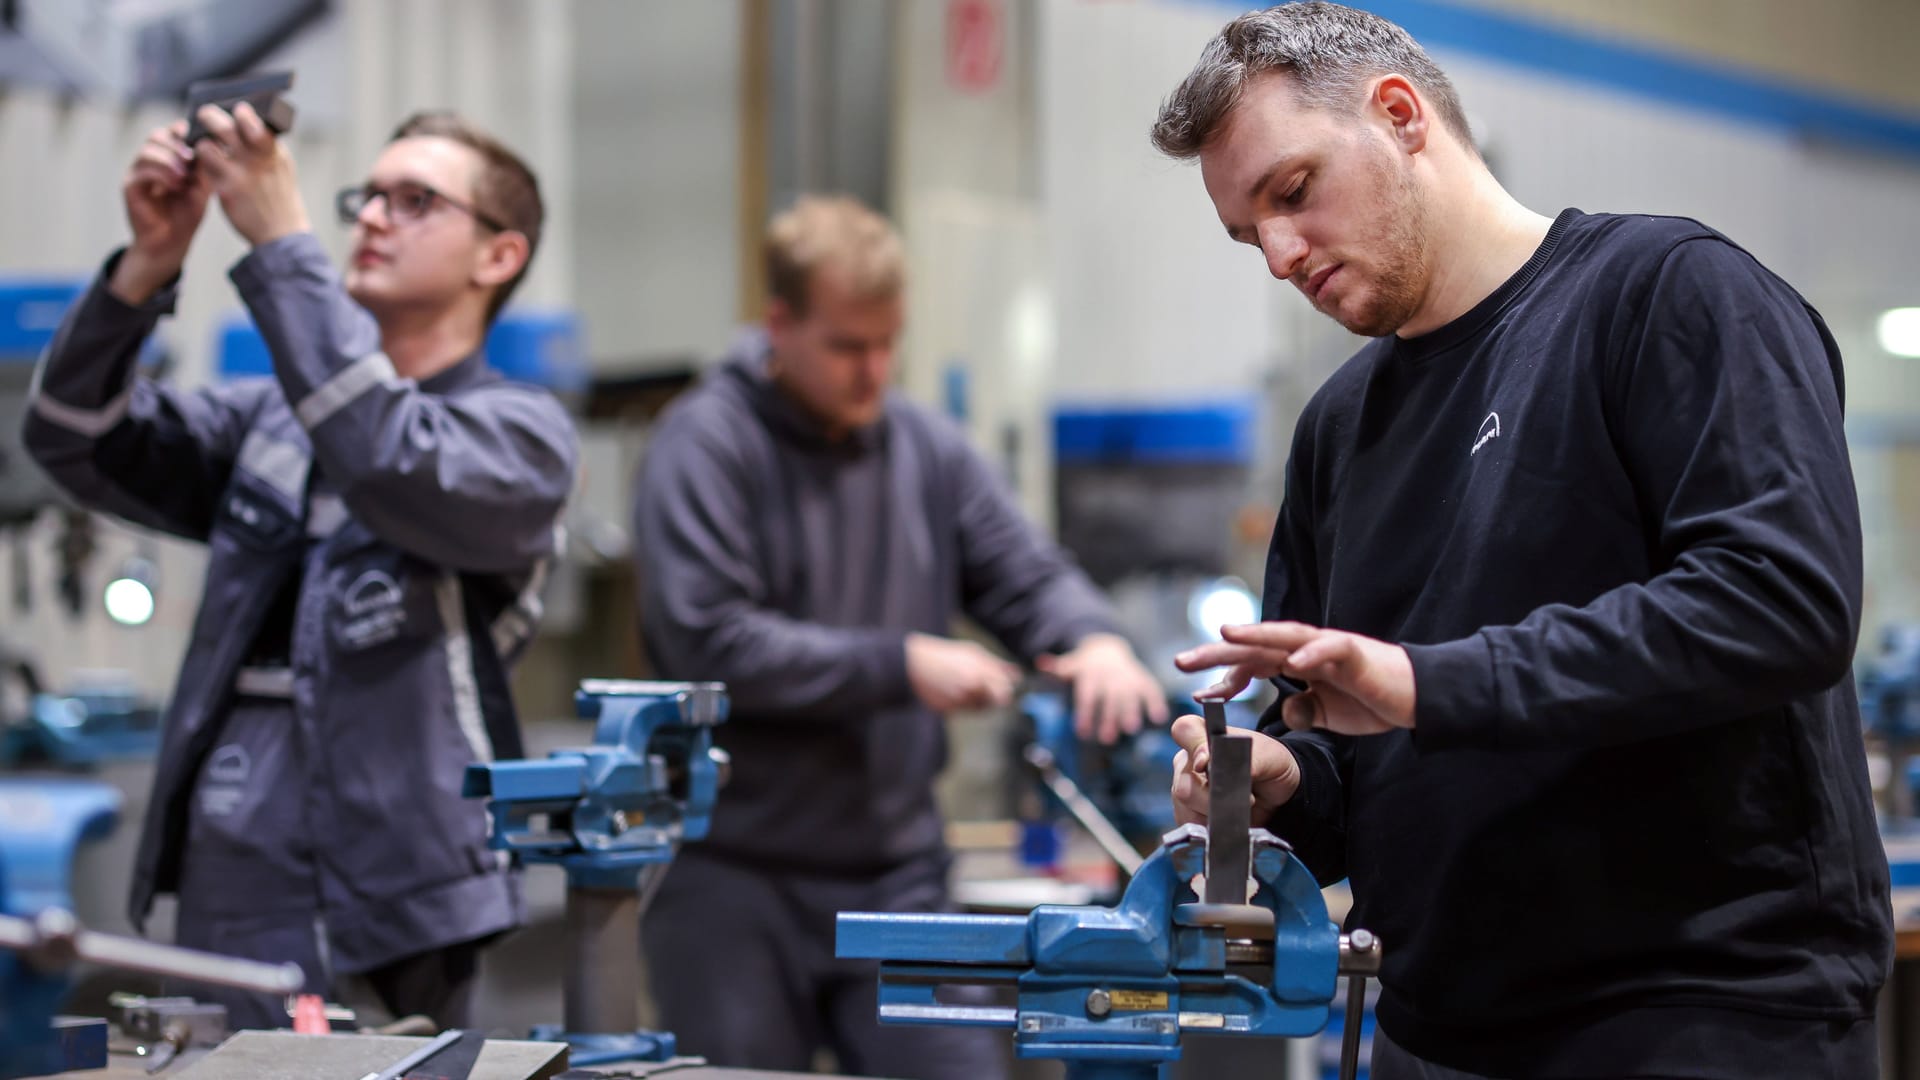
left=465, top=678, right=728, bottom=888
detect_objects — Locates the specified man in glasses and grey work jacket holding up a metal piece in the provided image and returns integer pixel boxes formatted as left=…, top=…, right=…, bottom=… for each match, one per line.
left=25, top=106, right=576, bottom=1026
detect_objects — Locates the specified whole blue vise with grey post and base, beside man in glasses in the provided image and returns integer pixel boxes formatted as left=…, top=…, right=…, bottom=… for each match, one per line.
left=463, top=678, right=728, bottom=1065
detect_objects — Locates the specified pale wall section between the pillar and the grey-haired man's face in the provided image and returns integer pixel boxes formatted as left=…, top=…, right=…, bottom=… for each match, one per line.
left=1039, top=2, right=1320, bottom=402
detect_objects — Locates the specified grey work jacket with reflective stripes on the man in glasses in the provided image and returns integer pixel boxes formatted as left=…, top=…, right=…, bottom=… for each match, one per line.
left=25, top=234, right=578, bottom=972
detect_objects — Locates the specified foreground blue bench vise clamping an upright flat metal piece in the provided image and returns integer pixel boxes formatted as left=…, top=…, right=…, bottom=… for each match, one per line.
left=835, top=701, right=1380, bottom=1080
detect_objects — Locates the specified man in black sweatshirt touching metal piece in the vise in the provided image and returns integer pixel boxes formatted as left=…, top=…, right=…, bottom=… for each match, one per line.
left=1154, top=4, right=1891, bottom=1080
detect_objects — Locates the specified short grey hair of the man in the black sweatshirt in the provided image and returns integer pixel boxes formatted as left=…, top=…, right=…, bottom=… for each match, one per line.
left=1152, top=0, right=1478, bottom=160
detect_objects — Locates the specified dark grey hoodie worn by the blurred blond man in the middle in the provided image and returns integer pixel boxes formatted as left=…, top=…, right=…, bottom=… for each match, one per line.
left=634, top=332, right=1117, bottom=876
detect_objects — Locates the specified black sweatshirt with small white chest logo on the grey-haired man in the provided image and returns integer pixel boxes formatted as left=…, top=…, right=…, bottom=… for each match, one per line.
left=1265, top=211, right=1891, bottom=1080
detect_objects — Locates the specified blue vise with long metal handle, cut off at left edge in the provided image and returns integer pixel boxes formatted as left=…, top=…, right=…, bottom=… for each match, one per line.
left=0, top=780, right=303, bottom=1080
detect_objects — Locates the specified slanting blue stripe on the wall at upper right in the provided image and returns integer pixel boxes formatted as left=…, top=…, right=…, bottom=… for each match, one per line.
left=1185, top=0, right=1920, bottom=158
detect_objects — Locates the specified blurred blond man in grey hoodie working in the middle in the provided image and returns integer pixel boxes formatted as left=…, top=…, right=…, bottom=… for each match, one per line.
left=636, top=198, right=1165, bottom=1080
